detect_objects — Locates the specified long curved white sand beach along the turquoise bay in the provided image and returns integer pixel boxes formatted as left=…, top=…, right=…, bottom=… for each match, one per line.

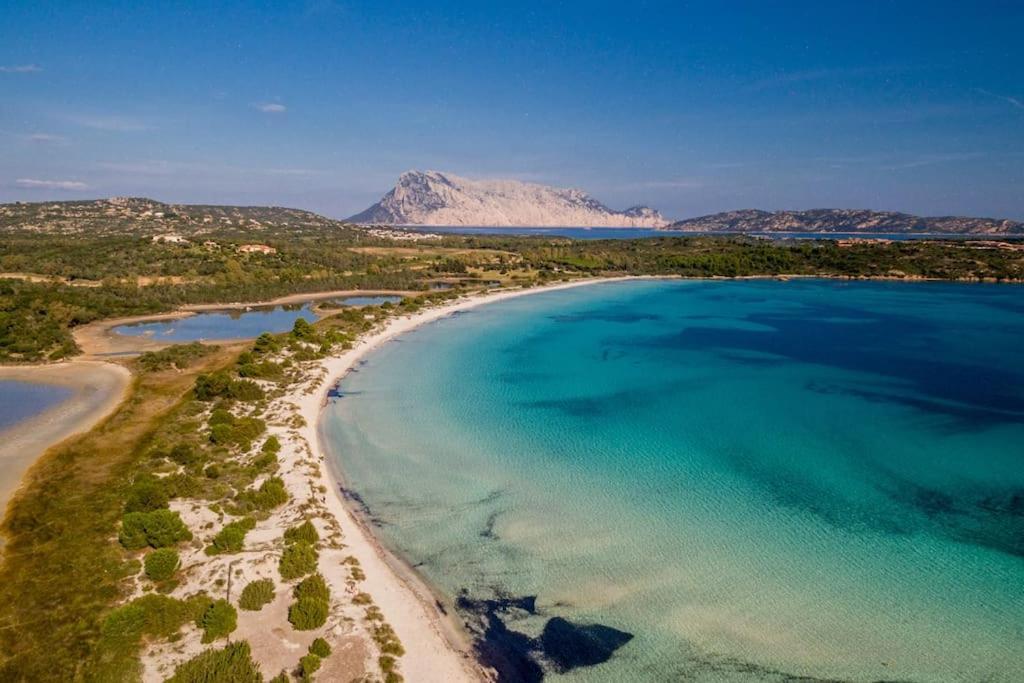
left=294, top=276, right=634, bottom=681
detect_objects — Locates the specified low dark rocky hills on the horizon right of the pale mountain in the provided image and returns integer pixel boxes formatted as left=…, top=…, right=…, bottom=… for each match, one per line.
left=665, top=209, right=1024, bottom=236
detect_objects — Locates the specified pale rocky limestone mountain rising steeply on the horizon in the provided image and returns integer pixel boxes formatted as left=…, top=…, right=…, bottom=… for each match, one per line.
left=347, top=171, right=669, bottom=227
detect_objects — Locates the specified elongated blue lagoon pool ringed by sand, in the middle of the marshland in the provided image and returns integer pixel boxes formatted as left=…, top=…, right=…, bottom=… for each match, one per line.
left=113, top=303, right=316, bottom=342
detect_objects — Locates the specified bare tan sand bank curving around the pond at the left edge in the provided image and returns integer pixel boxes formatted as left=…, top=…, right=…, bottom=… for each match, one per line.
left=0, top=360, right=131, bottom=532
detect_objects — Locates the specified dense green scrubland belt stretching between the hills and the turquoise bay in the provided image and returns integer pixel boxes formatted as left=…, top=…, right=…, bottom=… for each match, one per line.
left=0, top=203, right=1024, bottom=362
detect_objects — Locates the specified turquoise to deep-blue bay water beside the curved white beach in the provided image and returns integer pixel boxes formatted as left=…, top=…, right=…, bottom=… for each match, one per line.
left=323, top=281, right=1024, bottom=681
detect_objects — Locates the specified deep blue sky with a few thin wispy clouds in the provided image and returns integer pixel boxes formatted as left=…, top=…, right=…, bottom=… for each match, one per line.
left=0, top=0, right=1024, bottom=219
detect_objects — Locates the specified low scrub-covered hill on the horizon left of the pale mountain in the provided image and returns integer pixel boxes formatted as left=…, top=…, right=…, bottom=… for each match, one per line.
left=0, top=197, right=360, bottom=236
